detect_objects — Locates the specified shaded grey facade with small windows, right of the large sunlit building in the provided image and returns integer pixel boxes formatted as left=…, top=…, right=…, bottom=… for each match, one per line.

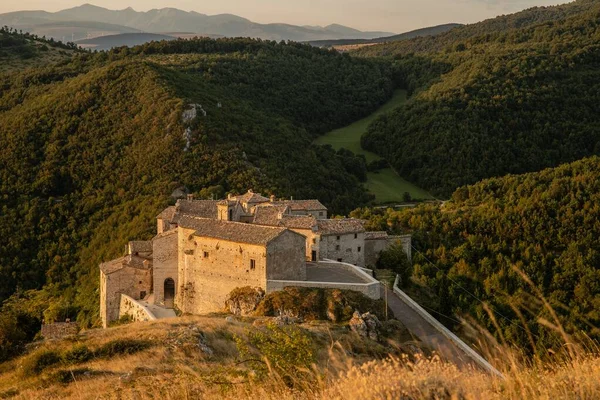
left=319, top=233, right=365, bottom=267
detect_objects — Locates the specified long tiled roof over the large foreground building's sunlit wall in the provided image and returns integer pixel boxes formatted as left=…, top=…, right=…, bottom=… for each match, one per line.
left=179, top=216, right=287, bottom=245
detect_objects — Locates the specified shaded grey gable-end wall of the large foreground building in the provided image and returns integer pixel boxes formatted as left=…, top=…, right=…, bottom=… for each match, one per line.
left=266, top=231, right=306, bottom=281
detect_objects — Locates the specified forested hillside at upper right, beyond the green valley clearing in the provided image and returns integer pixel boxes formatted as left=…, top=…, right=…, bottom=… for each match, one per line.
left=358, top=0, right=600, bottom=196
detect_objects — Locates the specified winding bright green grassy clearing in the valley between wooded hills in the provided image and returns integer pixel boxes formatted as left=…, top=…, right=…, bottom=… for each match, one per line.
left=315, top=90, right=433, bottom=204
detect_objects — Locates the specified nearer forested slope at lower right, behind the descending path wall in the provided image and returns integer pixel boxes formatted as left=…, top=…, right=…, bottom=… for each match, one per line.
left=353, top=157, right=600, bottom=354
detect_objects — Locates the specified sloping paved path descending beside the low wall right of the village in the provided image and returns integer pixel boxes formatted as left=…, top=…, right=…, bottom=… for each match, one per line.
left=381, top=285, right=475, bottom=367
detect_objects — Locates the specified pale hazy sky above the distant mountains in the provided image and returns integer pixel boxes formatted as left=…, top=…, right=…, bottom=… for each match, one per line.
left=0, top=0, right=567, bottom=33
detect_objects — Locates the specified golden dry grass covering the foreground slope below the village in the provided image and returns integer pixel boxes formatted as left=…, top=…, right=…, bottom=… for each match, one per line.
left=0, top=317, right=600, bottom=400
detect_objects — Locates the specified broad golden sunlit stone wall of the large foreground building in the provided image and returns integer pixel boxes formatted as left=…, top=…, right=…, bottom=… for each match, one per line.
left=175, top=227, right=267, bottom=314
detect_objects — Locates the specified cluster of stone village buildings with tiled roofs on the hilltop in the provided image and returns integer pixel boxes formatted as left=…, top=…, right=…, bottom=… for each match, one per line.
left=100, top=190, right=411, bottom=327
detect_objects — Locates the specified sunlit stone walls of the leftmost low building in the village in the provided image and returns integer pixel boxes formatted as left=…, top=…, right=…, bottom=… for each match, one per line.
left=100, top=267, right=152, bottom=328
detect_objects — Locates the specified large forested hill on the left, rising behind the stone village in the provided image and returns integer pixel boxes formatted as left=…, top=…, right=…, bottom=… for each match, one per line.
left=0, top=39, right=392, bottom=340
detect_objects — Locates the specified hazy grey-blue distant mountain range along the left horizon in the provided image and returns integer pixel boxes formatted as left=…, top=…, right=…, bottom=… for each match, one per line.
left=0, top=4, right=393, bottom=41
